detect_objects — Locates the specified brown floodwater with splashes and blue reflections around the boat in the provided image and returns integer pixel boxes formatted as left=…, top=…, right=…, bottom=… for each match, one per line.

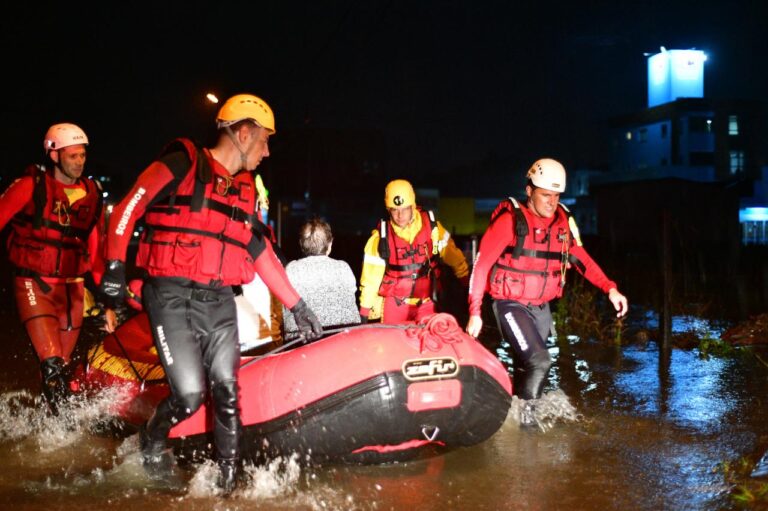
left=0, top=312, right=768, bottom=511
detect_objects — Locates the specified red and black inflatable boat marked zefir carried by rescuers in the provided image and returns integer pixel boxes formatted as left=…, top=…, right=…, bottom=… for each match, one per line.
left=79, top=313, right=512, bottom=463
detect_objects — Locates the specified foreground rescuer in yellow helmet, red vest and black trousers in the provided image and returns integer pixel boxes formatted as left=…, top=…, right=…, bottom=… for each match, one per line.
left=101, top=94, right=322, bottom=494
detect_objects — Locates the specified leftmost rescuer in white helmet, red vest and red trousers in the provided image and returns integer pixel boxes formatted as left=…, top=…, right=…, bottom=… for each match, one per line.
left=0, top=123, right=103, bottom=414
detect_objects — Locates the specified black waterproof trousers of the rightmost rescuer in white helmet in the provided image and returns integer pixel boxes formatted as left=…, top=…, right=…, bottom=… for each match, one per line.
left=493, top=300, right=552, bottom=399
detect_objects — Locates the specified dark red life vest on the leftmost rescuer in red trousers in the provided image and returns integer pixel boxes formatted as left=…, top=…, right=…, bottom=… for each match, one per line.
left=8, top=165, right=102, bottom=277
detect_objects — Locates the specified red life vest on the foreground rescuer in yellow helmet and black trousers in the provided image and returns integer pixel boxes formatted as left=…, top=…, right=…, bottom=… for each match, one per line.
left=136, top=139, right=256, bottom=286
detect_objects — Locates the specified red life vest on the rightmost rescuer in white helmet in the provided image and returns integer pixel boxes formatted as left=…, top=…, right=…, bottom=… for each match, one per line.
left=489, top=198, right=573, bottom=305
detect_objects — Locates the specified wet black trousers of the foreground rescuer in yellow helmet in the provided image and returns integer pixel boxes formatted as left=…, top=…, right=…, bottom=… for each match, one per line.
left=143, top=278, right=242, bottom=462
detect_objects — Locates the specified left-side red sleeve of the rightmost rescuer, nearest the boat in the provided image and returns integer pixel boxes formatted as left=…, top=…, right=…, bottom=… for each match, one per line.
left=469, top=212, right=515, bottom=316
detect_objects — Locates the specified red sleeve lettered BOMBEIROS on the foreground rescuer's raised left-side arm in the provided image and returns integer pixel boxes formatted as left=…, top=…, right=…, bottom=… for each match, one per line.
left=105, top=161, right=173, bottom=261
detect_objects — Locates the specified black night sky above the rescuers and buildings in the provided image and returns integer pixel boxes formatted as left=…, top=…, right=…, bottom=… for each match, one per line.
left=0, top=0, right=768, bottom=196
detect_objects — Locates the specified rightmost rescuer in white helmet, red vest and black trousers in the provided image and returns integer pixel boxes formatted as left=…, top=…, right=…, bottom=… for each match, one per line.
left=466, top=158, right=627, bottom=426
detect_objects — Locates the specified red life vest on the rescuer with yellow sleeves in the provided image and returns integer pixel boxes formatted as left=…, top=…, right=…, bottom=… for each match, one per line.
left=379, top=209, right=439, bottom=299
